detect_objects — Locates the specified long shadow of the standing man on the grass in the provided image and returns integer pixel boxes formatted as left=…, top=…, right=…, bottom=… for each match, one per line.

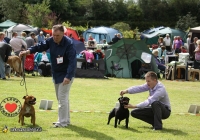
left=67, top=125, right=114, bottom=140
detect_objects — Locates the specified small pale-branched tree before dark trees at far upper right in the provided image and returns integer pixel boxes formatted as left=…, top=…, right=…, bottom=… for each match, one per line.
left=176, top=12, right=198, bottom=31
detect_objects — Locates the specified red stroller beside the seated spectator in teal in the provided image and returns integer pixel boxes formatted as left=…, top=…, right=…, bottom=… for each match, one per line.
left=24, top=54, right=38, bottom=76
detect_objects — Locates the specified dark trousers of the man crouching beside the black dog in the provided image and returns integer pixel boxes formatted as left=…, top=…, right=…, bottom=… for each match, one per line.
left=131, top=101, right=171, bottom=129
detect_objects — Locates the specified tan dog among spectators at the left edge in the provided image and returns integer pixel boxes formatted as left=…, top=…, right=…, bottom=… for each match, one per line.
left=6, top=55, right=22, bottom=76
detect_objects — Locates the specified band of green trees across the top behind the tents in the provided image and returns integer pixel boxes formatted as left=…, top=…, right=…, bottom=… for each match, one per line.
left=0, top=0, right=200, bottom=29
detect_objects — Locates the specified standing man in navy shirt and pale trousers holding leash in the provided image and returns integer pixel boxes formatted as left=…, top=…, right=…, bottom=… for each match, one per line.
left=20, top=25, right=76, bottom=127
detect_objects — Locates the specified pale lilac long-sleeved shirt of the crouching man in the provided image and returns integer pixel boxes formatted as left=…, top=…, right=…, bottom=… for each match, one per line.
left=128, top=82, right=171, bottom=110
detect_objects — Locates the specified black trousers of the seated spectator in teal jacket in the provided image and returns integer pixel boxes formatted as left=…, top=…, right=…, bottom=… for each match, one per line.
left=38, top=61, right=51, bottom=76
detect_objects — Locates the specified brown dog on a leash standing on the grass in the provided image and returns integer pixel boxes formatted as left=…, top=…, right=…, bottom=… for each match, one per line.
left=18, top=95, right=36, bottom=126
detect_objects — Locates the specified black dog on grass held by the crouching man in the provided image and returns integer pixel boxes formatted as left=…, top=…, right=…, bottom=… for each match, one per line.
left=107, top=97, right=130, bottom=128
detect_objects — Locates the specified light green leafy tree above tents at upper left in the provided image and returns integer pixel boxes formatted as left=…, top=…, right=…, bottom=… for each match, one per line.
left=25, top=0, right=51, bottom=28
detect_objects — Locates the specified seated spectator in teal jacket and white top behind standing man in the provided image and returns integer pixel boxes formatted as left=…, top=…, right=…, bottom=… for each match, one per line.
left=35, top=51, right=51, bottom=77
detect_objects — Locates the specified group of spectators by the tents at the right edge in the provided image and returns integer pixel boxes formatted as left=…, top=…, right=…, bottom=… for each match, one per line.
left=150, top=34, right=200, bottom=76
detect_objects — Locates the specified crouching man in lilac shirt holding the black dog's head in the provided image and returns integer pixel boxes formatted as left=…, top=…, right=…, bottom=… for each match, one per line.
left=120, top=71, right=171, bottom=130
